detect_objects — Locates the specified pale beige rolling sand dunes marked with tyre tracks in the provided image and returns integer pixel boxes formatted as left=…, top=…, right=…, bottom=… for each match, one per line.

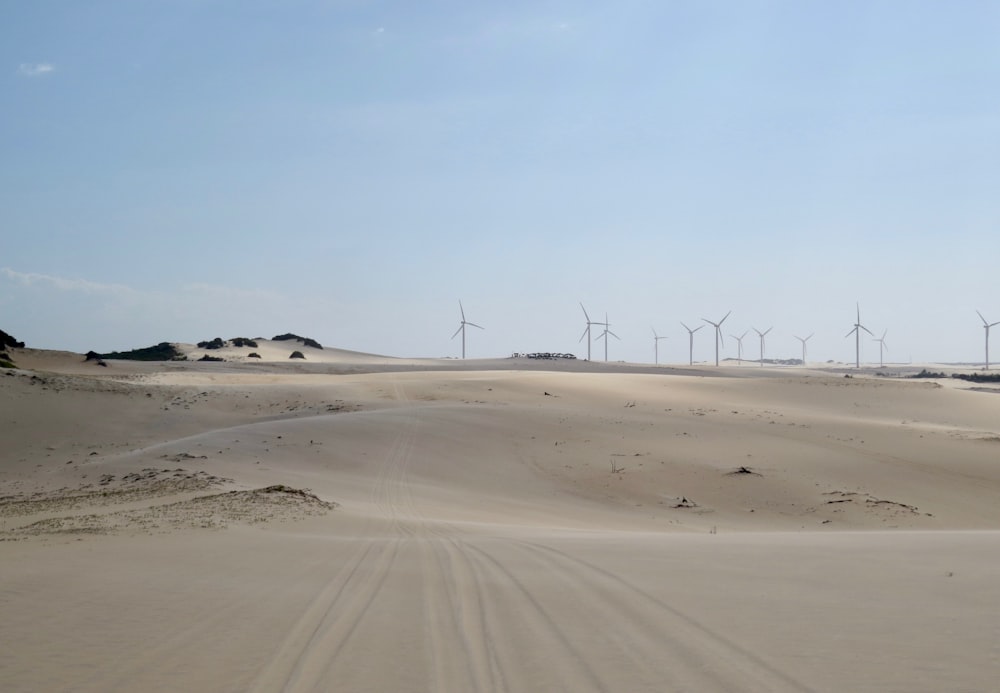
left=0, top=343, right=1000, bottom=692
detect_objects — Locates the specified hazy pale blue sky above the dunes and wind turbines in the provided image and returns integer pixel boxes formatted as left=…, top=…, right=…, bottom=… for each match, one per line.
left=0, top=0, right=1000, bottom=363
